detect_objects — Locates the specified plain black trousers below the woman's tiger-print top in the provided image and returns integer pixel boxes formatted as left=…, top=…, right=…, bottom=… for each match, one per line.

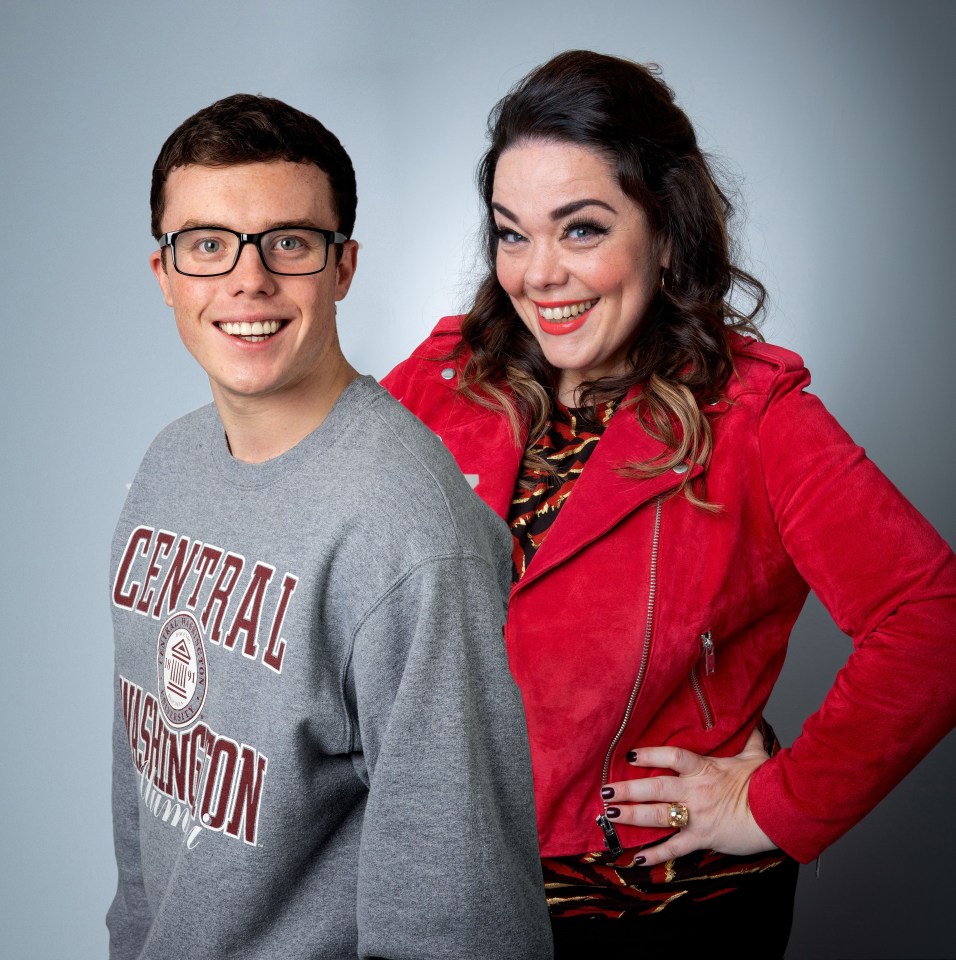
left=551, top=858, right=799, bottom=960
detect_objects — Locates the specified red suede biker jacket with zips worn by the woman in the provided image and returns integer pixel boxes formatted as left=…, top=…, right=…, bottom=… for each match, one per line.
left=383, top=317, right=956, bottom=862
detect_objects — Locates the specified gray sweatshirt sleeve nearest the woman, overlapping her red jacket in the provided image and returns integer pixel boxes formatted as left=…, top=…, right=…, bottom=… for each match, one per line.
left=352, top=557, right=551, bottom=960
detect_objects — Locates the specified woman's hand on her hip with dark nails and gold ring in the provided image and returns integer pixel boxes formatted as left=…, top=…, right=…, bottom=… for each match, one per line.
left=602, top=730, right=775, bottom=866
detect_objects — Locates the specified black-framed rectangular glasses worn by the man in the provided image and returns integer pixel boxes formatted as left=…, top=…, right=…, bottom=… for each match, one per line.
left=159, top=227, right=348, bottom=277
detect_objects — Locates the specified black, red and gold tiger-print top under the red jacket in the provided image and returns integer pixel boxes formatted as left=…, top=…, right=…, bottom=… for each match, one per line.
left=508, top=398, right=786, bottom=917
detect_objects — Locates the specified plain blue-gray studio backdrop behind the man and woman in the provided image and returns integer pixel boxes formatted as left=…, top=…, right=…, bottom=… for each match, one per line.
left=0, top=0, right=956, bottom=960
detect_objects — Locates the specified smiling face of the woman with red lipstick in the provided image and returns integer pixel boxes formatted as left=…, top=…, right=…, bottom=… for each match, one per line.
left=492, top=140, right=666, bottom=406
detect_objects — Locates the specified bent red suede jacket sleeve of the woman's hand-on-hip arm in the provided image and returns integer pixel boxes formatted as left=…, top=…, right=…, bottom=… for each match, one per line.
left=749, top=356, right=956, bottom=862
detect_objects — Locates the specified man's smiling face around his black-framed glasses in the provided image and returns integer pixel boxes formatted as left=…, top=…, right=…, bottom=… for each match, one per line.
left=150, top=160, right=357, bottom=410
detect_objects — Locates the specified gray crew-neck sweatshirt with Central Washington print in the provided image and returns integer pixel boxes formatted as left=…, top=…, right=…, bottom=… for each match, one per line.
left=107, top=378, right=551, bottom=960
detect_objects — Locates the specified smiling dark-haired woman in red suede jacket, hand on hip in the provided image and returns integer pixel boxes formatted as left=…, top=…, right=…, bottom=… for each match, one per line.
left=385, top=51, right=956, bottom=957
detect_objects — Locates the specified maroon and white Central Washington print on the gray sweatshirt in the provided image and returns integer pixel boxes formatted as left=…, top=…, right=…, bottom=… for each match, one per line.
left=112, top=526, right=299, bottom=849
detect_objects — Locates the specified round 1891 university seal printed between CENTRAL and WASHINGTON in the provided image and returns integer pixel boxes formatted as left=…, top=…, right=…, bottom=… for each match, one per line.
left=156, top=613, right=208, bottom=727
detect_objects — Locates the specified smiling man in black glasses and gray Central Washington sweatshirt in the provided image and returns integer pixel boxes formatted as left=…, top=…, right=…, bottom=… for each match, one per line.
left=107, top=95, right=550, bottom=960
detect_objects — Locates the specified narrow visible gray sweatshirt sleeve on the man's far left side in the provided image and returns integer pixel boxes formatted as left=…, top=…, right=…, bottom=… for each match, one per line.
left=106, top=677, right=150, bottom=960
